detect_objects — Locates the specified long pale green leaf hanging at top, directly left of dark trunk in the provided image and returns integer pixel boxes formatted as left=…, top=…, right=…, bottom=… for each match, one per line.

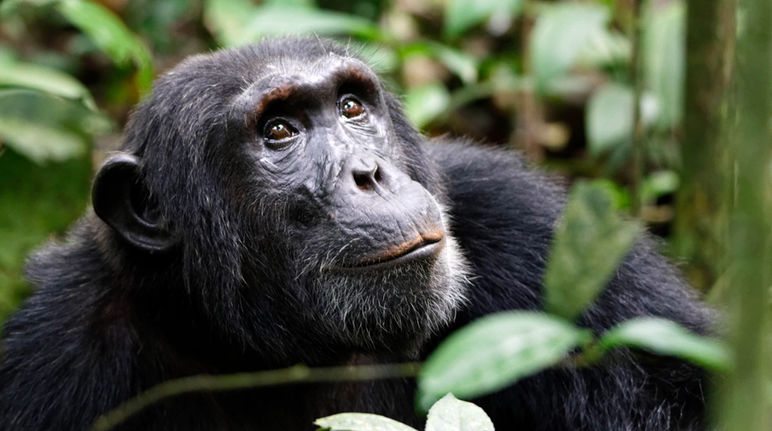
left=642, top=2, right=686, bottom=128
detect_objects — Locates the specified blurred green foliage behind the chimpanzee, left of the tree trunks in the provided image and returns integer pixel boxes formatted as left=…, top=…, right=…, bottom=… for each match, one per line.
left=0, top=0, right=714, bottom=321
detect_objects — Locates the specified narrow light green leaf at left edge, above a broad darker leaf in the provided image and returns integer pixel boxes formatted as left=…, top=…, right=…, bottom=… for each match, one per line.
left=0, top=59, right=96, bottom=109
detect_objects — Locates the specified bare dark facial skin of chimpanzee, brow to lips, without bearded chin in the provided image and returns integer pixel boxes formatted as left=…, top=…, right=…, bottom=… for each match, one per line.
left=235, top=57, right=445, bottom=272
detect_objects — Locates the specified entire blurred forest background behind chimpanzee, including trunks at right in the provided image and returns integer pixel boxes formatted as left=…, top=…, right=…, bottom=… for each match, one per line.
left=0, top=0, right=772, bottom=430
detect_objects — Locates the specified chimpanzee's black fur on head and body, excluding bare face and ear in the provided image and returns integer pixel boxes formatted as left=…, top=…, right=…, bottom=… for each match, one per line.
left=0, top=39, right=711, bottom=431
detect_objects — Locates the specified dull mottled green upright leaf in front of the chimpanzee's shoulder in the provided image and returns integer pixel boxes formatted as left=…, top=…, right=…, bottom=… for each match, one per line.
left=544, top=182, right=641, bottom=319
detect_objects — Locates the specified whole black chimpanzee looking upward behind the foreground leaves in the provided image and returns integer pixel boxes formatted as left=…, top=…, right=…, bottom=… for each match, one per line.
left=0, top=38, right=712, bottom=431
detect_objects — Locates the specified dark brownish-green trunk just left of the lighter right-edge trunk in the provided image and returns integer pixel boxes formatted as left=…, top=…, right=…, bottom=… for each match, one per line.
left=674, top=0, right=736, bottom=290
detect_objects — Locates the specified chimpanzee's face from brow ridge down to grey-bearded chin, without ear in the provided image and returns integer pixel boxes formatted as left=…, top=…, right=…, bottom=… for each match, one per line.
left=214, top=55, right=463, bottom=350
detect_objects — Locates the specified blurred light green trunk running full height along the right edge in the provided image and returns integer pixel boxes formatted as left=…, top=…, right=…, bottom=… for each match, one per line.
left=721, top=0, right=772, bottom=431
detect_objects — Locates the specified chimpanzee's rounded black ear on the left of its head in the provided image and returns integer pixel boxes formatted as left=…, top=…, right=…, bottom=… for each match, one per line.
left=91, top=153, right=177, bottom=253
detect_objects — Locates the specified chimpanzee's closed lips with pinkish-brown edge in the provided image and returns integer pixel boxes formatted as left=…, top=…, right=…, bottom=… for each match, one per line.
left=349, top=230, right=445, bottom=269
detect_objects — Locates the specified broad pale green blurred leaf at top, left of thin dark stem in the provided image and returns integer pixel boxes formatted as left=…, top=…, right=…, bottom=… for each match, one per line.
left=530, top=3, right=609, bottom=93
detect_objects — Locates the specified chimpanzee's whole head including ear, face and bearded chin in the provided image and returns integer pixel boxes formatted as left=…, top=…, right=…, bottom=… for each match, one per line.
left=89, top=39, right=464, bottom=355
